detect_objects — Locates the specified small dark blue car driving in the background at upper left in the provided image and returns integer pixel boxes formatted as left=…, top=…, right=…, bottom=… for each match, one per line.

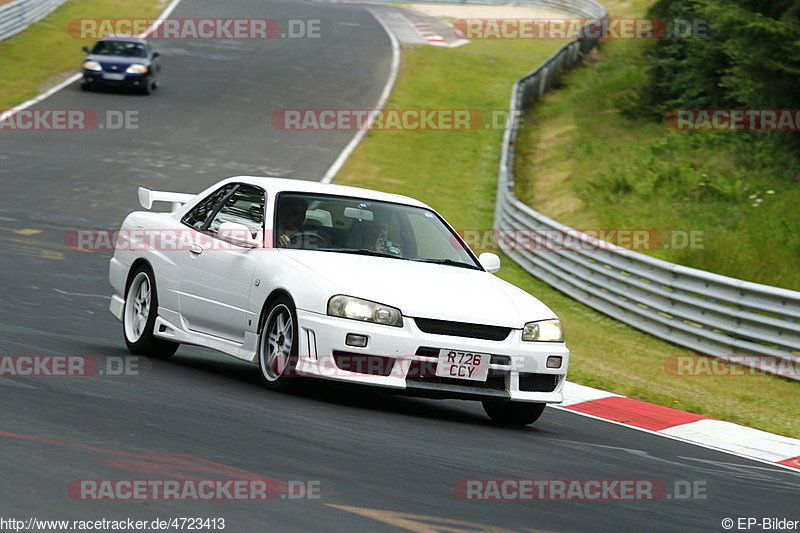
left=81, top=37, right=161, bottom=94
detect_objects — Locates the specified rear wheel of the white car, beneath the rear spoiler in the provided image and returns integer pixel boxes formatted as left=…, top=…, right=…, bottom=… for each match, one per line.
left=122, top=265, right=180, bottom=359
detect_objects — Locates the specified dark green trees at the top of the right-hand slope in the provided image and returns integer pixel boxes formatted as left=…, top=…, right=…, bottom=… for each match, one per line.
left=635, top=0, right=800, bottom=120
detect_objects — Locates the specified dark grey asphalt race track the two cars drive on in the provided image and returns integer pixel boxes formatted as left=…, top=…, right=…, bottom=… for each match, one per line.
left=0, top=0, right=800, bottom=533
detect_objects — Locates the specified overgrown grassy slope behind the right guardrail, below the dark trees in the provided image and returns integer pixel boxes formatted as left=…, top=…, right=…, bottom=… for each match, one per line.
left=515, top=4, right=800, bottom=290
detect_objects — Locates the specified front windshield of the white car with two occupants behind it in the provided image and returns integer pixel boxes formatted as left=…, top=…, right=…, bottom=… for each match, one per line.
left=275, top=193, right=481, bottom=269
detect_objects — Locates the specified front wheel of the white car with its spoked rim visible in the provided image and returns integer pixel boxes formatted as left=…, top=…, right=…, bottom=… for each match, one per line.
left=258, top=295, right=300, bottom=392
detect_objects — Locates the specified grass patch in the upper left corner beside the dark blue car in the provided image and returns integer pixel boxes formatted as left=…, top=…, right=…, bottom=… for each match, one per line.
left=0, top=0, right=167, bottom=109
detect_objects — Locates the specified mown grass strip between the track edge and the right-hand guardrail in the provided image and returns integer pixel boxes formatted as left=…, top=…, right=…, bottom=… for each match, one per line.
left=336, top=41, right=800, bottom=437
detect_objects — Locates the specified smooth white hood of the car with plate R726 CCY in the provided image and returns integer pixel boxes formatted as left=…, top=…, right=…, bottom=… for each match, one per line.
left=281, top=249, right=555, bottom=329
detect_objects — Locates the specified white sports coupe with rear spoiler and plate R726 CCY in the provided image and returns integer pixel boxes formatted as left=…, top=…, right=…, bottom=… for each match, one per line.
left=109, top=176, right=569, bottom=425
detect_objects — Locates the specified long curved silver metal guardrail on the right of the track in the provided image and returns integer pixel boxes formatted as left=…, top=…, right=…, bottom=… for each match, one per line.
left=494, top=0, right=800, bottom=379
